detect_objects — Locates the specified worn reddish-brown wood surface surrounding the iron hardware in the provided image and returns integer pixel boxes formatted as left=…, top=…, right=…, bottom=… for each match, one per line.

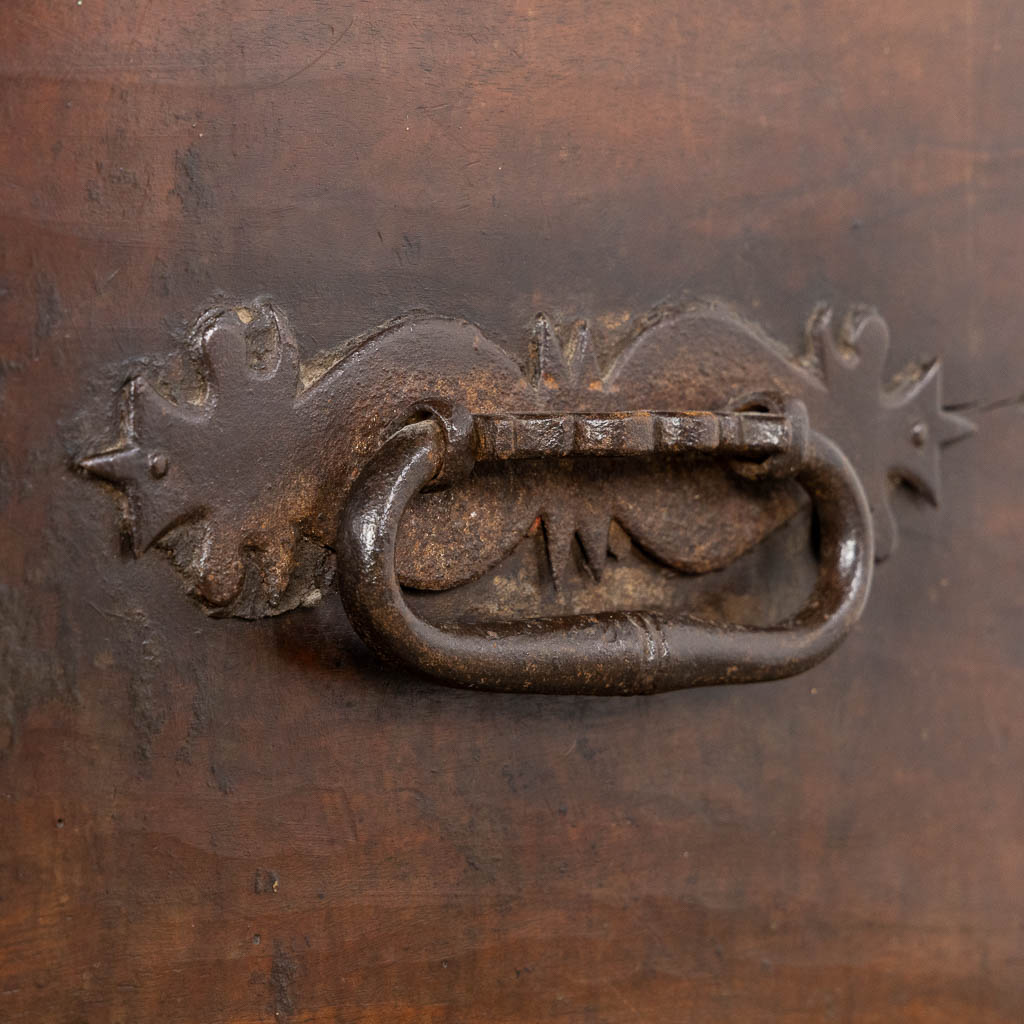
left=0, top=0, right=1024, bottom=1024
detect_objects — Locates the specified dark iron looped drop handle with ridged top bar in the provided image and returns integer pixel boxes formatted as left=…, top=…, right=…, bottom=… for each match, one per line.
left=338, top=396, right=873, bottom=695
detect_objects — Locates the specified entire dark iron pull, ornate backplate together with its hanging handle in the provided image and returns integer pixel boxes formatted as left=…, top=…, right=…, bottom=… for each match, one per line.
left=75, top=300, right=973, bottom=694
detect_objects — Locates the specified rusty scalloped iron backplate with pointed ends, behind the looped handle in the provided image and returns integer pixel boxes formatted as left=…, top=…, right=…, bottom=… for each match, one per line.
left=77, top=292, right=973, bottom=617
